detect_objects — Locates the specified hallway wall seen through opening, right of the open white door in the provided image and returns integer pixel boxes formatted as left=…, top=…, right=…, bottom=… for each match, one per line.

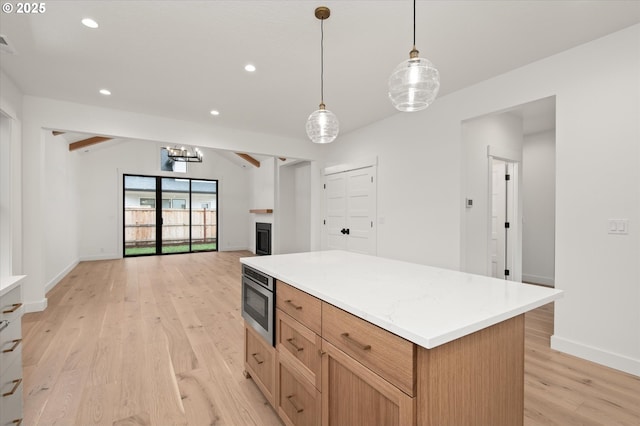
left=522, top=130, right=556, bottom=286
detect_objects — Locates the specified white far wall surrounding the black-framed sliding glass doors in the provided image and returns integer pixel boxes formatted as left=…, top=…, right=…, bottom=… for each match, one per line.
left=75, top=140, right=249, bottom=260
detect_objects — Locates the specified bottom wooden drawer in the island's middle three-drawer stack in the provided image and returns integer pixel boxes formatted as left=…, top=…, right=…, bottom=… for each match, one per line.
left=277, top=363, right=322, bottom=426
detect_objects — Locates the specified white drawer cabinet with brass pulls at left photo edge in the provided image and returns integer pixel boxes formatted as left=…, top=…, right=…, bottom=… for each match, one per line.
left=0, top=276, right=24, bottom=426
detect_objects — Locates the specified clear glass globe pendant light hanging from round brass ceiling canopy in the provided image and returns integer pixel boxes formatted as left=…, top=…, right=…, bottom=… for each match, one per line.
left=307, top=6, right=340, bottom=143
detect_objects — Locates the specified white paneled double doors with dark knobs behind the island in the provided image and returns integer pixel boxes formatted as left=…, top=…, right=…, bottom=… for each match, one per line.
left=324, top=167, right=376, bottom=255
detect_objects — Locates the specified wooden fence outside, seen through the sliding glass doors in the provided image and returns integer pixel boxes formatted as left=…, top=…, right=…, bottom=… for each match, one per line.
left=124, top=207, right=218, bottom=247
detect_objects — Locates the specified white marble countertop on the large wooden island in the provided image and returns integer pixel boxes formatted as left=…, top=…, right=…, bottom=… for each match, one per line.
left=240, top=250, right=562, bottom=349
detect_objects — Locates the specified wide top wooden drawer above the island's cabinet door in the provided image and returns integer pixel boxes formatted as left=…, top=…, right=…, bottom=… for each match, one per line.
left=322, top=303, right=416, bottom=396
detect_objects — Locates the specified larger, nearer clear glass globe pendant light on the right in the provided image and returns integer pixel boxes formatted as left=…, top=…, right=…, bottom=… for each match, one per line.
left=389, top=0, right=440, bottom=112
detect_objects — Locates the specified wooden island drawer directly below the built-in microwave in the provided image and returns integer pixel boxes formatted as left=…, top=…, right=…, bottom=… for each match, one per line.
left=244, top=326, right=276, bottom=405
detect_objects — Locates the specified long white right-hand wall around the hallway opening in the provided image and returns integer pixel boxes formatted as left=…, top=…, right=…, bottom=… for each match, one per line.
left=327, top=25, right=640, bottom=375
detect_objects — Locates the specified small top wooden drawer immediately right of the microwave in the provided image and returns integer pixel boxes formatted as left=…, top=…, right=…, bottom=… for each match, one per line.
left=276, top=281, right=322, bottom=334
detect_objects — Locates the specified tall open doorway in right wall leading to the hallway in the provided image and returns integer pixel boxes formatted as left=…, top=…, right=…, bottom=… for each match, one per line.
left=460, top=96, right=556, bottom=286
